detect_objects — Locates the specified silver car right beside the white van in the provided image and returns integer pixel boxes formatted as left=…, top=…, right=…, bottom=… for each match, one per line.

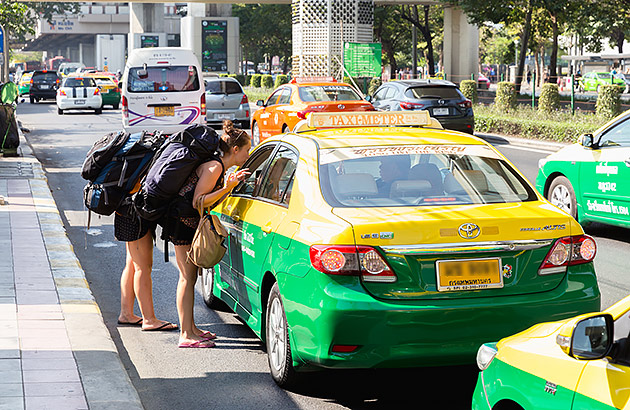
left=204, top=77, right=251, bottom=129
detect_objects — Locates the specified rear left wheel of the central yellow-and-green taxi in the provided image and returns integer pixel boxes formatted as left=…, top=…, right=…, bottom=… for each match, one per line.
left=265, top=283, right=298, bottom=388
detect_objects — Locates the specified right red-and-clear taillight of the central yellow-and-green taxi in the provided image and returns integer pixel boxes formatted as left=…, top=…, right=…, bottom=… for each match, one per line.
left=538, top=235, right=597, bottom=275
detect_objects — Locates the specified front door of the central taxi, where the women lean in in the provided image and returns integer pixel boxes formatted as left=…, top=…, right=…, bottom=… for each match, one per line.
left=219, top=143, right=276, bottom=301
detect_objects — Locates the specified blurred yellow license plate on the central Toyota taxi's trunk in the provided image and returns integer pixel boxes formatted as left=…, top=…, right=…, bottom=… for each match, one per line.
left=435, top=258, right=503, bottom=292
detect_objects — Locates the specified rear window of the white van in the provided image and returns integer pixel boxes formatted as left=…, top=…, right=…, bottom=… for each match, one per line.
left=127, top=66, right=199, bottom=93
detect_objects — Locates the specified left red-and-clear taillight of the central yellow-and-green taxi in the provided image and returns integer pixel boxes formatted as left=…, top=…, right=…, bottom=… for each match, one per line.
left=310, top=245, right=397, bottom=282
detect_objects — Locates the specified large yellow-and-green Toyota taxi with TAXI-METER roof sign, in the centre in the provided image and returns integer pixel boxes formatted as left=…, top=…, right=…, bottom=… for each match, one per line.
left=202, top=111, right=600, bottom=386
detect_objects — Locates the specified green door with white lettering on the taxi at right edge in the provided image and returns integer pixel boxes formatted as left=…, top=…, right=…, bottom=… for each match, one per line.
left=574, top=119, right=630, bottom=227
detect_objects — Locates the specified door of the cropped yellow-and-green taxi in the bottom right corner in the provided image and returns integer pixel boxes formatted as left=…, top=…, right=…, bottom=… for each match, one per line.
left=572, top=311, right=630, bottom=410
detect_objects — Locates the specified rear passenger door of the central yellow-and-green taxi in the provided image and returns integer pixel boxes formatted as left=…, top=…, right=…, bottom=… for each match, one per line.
left=234, top=144, right=298, bottom=320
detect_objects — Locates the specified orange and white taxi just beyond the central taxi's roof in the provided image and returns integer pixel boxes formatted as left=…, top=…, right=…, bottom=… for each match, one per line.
left=252, top=77, right=375, bottom=145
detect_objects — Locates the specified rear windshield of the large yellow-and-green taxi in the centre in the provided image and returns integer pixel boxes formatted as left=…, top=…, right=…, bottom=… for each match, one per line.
left=319, top=145, right=537, bottom=208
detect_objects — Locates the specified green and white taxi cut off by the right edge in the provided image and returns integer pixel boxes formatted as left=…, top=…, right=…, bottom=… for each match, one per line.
left=536, top=111, right=630, bottom=227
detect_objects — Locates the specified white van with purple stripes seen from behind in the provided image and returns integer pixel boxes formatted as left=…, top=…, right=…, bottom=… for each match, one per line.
left=121, top=47, right=206, bottom=134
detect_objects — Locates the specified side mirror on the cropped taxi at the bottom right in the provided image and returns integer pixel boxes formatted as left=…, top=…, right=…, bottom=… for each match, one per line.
left=556, top=313, right=614, bottom=360
